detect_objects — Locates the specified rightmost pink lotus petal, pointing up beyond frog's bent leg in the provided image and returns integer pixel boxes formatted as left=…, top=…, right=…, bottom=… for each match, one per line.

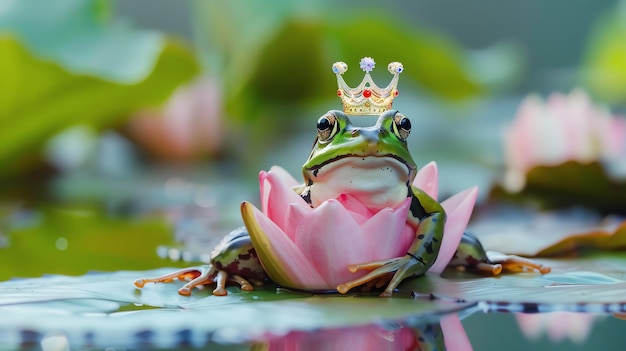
left=430, top=187, right=478, bottom=273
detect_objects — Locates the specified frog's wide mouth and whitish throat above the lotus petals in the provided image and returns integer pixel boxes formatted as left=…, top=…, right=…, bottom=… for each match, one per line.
left=306, top=154, right=415, bottom=210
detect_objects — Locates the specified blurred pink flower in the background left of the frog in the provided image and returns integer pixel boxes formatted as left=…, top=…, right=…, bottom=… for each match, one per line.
left=129, top=77, right=223, bottom=161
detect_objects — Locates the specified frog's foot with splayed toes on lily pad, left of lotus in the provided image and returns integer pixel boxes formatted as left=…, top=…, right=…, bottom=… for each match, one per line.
left=135, top=265, right=254, bottom=296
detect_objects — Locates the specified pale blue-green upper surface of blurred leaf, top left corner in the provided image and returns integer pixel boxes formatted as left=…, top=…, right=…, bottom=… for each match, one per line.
left=0, top=0, right=167, bottom=84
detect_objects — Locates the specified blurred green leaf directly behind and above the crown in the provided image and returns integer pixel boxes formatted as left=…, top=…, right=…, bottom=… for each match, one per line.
left=328, top=14, right=483, bottom=99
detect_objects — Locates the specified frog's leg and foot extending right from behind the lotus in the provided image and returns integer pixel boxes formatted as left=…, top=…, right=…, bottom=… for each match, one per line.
left=448, top=231, right=551, bottom=275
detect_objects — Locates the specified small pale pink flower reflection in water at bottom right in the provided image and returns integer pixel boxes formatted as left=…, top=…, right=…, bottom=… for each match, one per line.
left=515, top=312, right=597, bottom=344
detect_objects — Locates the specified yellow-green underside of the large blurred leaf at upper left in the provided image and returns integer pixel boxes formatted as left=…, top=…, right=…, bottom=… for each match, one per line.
left=0, top=36, right=197, bottom=173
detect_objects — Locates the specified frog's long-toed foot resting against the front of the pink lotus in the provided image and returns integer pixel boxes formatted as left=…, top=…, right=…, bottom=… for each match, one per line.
left=337, top=254, right=424, bottom=297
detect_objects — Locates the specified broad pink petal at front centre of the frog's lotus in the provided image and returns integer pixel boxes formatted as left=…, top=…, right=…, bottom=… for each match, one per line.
left=296, top=200, right=371, bottom=289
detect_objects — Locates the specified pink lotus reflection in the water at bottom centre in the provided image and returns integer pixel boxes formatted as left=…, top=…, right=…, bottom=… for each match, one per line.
left=252, top=314, right=472, bottom=351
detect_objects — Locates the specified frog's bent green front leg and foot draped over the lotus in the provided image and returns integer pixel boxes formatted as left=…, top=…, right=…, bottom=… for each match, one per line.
left=337, top=187, right=446, bottom=296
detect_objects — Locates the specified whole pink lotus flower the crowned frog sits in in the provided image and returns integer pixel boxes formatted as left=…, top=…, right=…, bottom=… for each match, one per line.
left=242, top=163, right=477, bottom=290
